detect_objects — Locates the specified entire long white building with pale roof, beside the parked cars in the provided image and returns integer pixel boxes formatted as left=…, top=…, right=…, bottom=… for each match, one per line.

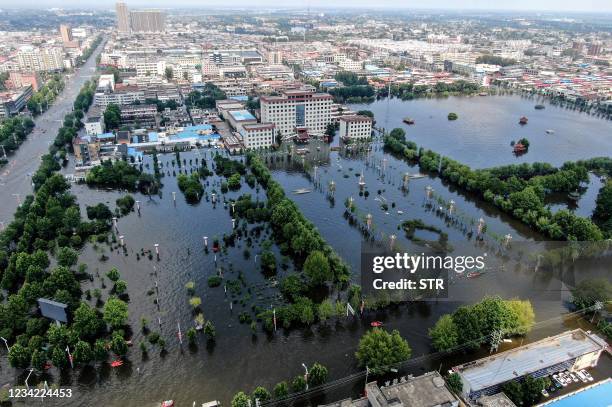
left=453, top=329, right=607, bottom=401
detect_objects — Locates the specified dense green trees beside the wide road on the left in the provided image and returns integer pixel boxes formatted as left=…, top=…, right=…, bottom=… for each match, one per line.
left=0, top=75, right=132, bottom=371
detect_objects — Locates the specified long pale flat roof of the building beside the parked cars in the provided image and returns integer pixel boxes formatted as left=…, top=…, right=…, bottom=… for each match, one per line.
left=453, top=329, right=606, bottom=392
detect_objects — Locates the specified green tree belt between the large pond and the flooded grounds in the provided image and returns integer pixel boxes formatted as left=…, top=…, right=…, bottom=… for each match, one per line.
left=384, top=129, right=606, bottom=241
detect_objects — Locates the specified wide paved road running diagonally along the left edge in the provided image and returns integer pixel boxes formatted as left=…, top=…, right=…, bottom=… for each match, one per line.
left=0, top=40, right=106, bottom=225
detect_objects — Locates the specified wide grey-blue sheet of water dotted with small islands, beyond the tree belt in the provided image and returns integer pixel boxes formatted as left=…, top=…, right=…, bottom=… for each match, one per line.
left=350, top=95, right=612, bottom=168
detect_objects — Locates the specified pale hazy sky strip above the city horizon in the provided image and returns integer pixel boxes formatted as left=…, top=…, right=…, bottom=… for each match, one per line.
left=0, top=0, right=612, bottom=12
